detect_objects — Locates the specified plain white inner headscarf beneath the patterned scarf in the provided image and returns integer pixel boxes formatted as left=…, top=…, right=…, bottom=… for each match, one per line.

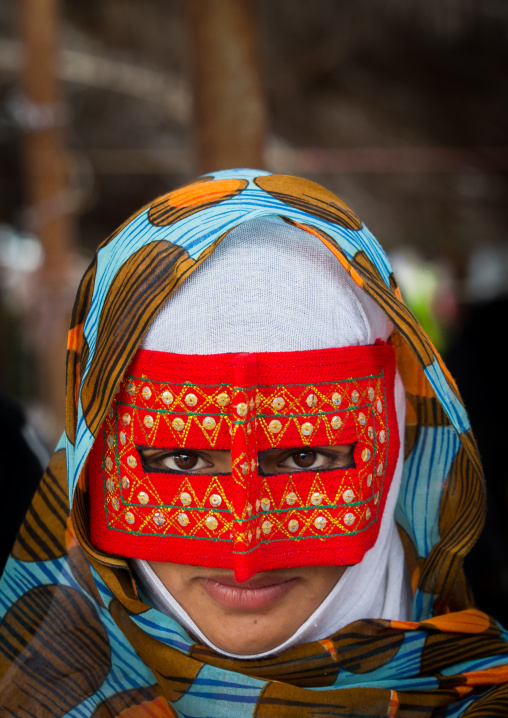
left=131, top=217, right=411, bottom=659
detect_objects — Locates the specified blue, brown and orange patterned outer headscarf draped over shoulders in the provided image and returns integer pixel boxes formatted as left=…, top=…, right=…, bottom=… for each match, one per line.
left=0, top=170, right=508, bottom=718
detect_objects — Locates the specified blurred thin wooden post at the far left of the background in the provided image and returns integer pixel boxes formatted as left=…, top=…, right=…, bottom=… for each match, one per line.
left=18, top=0, right=75, bottom=441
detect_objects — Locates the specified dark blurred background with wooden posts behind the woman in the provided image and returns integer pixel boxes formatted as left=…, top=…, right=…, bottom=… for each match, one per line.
left=0, top=0, right=508, bottom=623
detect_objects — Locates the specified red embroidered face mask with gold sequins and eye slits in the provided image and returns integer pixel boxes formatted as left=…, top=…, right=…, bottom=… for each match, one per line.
left=89, top=341, right=399, bottom=581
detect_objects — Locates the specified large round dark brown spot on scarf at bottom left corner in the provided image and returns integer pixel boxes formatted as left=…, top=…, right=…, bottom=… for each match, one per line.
left=0, top=585, right=111, bottom=718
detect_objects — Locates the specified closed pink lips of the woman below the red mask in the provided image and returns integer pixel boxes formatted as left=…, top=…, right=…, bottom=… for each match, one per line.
left=199, top=576, right=299, bottom=611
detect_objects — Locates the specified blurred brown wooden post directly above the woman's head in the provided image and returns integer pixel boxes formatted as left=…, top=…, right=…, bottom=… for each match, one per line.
left=187, top=0, right=266, bottom=172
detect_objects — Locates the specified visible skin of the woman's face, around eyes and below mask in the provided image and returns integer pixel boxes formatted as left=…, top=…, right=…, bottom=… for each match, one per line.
left=142, top=445, right=354, bottom=655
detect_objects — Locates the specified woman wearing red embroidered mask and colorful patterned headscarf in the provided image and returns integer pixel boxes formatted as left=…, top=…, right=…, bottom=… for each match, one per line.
left=0, top=170, right=508, bottom=718
